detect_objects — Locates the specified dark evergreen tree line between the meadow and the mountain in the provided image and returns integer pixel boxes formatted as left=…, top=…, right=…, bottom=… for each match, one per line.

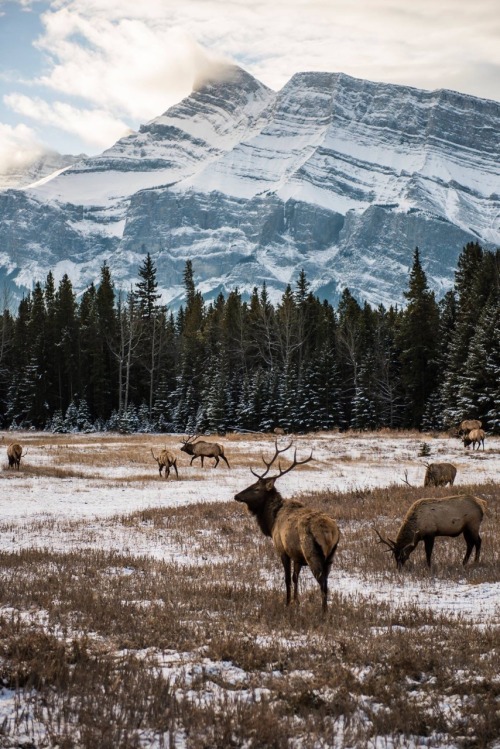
left=0, top=243, right=500, bottom=433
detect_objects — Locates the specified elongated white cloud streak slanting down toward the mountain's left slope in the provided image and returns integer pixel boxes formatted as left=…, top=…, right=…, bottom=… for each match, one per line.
left=4, top=94, right=130, bottom=148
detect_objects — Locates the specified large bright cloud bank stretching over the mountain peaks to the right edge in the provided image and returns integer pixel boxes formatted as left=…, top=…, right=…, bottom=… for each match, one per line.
left=34, top=0, right=500, bottom=108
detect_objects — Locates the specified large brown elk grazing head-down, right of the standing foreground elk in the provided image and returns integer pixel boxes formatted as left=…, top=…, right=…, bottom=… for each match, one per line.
left=375, top=494, right=487, bottom=569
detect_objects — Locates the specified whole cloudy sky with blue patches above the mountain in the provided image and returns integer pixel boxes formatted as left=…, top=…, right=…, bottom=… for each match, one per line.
left=0, top=0, right=500, bottom=172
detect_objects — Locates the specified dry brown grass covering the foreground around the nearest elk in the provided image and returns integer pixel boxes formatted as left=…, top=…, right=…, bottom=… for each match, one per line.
left=0, top=474, right=500, bottom=749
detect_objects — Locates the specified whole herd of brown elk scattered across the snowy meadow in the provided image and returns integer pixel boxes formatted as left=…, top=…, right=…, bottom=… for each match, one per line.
left=2, top=419, right=492, bottom=611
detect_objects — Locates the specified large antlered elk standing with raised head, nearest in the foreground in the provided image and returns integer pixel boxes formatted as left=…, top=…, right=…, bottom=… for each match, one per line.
left=234, top=440, right=340, bottom=611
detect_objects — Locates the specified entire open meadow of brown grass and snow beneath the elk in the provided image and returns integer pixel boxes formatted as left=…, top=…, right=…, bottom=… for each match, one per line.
left=0, top=431, right=500, bottom=749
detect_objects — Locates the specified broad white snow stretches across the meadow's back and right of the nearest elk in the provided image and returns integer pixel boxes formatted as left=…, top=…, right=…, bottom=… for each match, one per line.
left=0, top=426, right=500, bottom=622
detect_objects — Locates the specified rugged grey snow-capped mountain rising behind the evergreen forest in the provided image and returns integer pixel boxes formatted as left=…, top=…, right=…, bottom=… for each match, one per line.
left=0, top=68, right=500, bottom=305
